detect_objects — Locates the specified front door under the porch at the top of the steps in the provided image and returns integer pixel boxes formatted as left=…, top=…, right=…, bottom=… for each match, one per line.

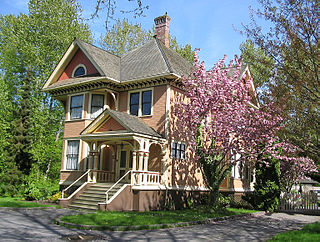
left=117, top=146, right=132, bottom=182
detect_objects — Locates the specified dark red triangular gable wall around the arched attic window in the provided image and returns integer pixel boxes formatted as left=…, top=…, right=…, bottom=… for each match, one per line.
left=58, top=49, right=100, bottom=81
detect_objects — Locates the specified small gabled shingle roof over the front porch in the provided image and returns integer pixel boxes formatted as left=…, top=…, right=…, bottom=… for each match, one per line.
left=81, top=109, right=162, bottom=138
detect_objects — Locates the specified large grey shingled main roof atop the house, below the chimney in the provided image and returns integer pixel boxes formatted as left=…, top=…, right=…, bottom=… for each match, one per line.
left=43, top=38, right=192, bottom=91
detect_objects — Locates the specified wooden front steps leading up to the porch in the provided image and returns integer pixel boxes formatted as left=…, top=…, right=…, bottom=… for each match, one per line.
left=68, top=183, right=124, bottom=212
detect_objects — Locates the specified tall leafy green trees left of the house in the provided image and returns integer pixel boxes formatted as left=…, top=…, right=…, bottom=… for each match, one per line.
left=0, top=0, right=91, bottom=197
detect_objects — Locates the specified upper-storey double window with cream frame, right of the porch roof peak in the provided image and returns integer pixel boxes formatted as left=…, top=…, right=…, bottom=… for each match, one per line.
left=129, top=90, right=152, bottom=116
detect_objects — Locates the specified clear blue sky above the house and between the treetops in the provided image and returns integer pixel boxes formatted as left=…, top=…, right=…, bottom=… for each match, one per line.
left=0, top=0, right=264, bottom=68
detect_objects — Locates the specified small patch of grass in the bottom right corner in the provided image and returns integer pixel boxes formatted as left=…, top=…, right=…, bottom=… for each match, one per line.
left=269, top=222, right=320, bottom=241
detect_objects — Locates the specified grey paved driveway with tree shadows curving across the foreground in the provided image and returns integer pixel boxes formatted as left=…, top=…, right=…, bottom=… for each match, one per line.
left=0, top=208, right=320, bottom=241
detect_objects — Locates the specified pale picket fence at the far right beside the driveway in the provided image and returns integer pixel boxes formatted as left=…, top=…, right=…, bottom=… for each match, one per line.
left=279, top=192, right=320, bottom=215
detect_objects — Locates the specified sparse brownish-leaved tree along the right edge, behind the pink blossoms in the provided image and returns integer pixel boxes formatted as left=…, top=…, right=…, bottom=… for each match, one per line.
left=244, top=0, right=320, bottom=164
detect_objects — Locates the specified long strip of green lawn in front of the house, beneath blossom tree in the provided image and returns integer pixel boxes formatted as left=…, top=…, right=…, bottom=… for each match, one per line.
left=61, top=207, right=256, bottom=227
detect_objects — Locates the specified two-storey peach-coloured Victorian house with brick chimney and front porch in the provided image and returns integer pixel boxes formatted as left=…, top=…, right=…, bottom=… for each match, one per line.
left=43, top=15, right=254, bottom=211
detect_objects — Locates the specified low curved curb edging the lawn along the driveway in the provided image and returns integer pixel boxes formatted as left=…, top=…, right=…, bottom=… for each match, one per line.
left=53, top=213, right=259, bottom=231
